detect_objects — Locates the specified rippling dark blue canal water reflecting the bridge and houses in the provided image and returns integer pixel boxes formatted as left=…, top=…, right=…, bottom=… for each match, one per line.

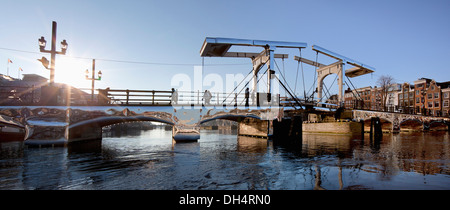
left=0, top=127, right=450, bottom=190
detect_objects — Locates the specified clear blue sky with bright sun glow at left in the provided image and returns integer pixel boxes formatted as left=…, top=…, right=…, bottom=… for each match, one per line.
left=0, top=0, right=450, bottom=97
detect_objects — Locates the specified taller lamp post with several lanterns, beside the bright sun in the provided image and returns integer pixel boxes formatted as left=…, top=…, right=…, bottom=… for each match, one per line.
left=38, top=21, right=68, bottom=86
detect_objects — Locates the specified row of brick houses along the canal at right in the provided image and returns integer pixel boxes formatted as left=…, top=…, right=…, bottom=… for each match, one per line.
left=344, top=78, right=450, bottom=116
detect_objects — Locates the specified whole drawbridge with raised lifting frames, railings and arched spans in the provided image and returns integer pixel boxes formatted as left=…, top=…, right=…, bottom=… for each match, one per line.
left=0, top=37, right=375, bottom=145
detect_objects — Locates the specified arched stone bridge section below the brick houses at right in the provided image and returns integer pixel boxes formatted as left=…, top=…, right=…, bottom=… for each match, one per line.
left=352, top=110, right=450, bottom=131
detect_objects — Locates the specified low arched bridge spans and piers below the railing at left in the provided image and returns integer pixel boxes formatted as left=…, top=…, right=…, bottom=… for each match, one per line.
left=0, top=106, right=283, bottom=145
